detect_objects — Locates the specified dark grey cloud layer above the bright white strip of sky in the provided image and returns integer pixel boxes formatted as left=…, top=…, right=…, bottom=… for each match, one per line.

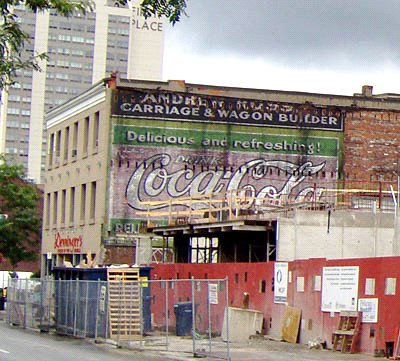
left=170, top=0, right=400, bottom=69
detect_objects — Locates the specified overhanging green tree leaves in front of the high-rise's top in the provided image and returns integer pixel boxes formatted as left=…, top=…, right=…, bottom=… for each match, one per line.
left=0, top=0, right=186, bottom=91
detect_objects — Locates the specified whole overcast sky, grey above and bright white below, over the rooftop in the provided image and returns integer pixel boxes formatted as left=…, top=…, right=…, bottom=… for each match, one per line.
left=163, top=0, right=400, bottom=95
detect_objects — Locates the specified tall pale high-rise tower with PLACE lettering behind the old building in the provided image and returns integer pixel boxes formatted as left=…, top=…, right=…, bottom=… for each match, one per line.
left=0, top=0, right=164, bottom=182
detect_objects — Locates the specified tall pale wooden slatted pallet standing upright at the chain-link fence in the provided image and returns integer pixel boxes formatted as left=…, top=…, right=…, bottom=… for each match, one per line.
left=107, top=268, right=142, bottom=340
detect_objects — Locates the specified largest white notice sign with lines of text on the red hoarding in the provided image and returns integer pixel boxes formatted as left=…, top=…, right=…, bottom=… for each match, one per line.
left=321, top=266, right=359, bottom=312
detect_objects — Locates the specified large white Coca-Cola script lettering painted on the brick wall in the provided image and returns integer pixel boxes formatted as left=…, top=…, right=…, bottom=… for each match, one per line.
left=126, top=154, right=325, bottom=210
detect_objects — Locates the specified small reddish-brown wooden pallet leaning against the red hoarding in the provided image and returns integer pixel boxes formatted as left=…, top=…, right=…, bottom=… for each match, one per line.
left=333, top=311, right=361, bottom=353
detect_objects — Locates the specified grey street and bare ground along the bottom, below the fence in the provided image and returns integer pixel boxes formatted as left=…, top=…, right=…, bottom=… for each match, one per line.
left=0, top=321, right=384, bottom=361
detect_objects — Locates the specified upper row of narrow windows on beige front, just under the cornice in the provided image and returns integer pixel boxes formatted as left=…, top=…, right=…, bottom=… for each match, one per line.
left=48, top=112, right=100, bottom=169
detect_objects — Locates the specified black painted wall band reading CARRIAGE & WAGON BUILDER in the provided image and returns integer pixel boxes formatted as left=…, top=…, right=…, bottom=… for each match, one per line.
left=113, top=90, right=344, bottom=130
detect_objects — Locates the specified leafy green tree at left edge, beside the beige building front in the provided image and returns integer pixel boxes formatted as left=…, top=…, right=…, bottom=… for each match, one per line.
left=0, top=156, right=41, bottom=266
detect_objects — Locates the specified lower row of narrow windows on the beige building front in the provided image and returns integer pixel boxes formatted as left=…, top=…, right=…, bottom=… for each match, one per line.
left=44, top=181, right=97, bottom=229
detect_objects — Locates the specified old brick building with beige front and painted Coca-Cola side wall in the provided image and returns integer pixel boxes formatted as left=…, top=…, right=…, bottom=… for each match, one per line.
left=42, top=77, right=400, bottom=269
